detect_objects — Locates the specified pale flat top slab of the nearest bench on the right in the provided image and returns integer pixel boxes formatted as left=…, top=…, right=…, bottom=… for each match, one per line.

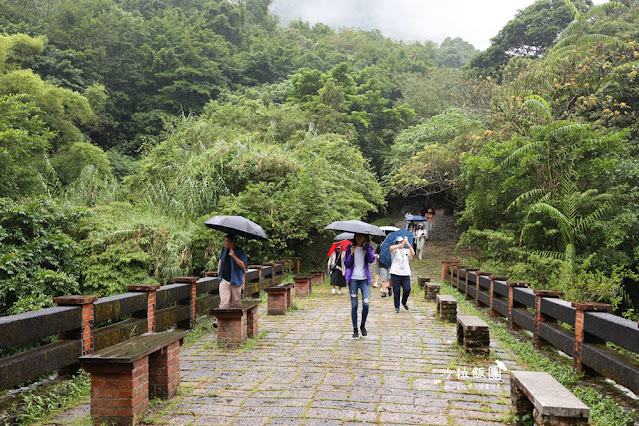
left=510, top=371, right=590, bottom=424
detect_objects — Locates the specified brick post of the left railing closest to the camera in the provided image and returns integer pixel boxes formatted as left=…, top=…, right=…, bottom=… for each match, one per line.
left=53, top=296, right=98, bottom=377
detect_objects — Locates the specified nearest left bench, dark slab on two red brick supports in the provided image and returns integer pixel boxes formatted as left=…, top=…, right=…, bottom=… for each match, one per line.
left=79, top=331, right=186, bottom=425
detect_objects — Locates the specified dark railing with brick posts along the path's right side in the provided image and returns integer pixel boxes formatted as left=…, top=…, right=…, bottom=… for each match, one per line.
left=442, top=260, right=639, bottom=393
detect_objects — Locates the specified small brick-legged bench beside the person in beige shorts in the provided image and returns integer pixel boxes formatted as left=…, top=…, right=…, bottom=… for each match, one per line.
left=213, top=299, right=261, bottom=347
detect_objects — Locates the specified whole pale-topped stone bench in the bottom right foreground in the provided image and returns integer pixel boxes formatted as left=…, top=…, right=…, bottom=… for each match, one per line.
left=510, top=371, right=590, bottom=426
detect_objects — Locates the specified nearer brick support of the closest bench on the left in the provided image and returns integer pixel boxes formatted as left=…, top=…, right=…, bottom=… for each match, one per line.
left=84, top=357, right=149, bottom=425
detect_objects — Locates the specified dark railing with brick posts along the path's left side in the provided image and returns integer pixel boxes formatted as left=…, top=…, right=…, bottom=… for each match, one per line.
left=0, top=260, right=299, bottom=391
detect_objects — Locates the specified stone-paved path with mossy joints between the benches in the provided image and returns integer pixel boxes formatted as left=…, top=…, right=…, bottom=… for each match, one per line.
left=141, top=286, right=516, bottom=425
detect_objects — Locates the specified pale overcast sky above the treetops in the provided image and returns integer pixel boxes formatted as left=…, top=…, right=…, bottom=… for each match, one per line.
left=273, top=0, right=607, bottom=50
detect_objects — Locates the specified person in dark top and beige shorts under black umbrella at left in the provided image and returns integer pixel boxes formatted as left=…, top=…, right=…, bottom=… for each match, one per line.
left=217, top=234, right=248, bottom=305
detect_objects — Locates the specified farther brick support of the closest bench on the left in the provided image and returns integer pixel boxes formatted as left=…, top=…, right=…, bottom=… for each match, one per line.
left=149, top=339, right=184, bottom=399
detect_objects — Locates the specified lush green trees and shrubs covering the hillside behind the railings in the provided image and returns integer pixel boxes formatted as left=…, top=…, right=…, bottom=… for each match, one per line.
left=0, top=0, right=639, bottom=317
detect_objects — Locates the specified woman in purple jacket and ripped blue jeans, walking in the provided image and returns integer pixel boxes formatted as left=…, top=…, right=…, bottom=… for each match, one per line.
left=344, top=234, right=375, bottom=339
